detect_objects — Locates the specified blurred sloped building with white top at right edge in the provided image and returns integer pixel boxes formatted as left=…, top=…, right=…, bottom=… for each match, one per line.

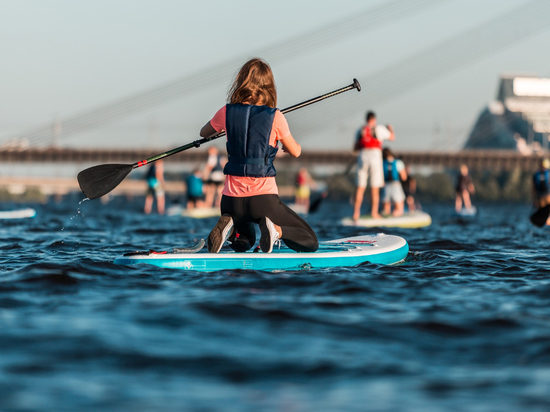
left=464, top=76, right=550, bottom=155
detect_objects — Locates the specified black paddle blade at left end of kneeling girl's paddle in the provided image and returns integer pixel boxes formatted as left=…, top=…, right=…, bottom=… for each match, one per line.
left=77, top=165, right=134, bottom=199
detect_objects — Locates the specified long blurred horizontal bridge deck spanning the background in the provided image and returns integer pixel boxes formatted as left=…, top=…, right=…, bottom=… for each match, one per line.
left=0, top=148, right=541, bottom=172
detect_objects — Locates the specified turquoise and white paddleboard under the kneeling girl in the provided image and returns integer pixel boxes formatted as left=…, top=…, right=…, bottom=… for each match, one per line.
left=115, top=234, right=409, bottom=272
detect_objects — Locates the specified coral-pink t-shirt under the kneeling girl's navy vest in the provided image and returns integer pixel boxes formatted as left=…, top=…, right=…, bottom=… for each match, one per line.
left=210, top=106, right=290, bottom=197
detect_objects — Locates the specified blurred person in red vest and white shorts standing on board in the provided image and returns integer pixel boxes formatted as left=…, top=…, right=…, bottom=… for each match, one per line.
left=353, top=112, right=395, bottom=221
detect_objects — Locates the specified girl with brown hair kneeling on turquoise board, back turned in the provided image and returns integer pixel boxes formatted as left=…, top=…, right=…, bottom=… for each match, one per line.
left=200, top=59, right=319, bottom=253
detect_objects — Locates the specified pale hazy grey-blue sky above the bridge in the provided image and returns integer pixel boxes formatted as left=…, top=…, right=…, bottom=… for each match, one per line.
left=0, top=0, right=550, bottom=150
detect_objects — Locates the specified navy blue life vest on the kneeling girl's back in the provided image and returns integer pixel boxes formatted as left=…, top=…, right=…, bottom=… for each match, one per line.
left=223, top=104, right=279, bottom=177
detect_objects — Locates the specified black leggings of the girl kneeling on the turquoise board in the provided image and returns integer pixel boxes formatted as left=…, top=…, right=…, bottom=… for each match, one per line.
left=221, top=195, right=319, bottom=252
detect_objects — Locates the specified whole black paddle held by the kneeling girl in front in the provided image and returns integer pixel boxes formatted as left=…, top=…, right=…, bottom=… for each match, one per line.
left=77, top=79, right=361, bottom=199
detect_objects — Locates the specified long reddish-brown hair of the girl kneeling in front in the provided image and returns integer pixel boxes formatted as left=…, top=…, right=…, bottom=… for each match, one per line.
left=228, top=58, right=277, bottom=108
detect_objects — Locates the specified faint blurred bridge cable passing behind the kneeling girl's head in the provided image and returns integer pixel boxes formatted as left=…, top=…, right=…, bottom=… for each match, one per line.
left=6, top=0, right=451, bottom=144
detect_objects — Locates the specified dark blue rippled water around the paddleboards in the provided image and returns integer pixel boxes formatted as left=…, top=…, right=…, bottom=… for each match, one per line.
left=0, top=199, right=550, bottom=411
